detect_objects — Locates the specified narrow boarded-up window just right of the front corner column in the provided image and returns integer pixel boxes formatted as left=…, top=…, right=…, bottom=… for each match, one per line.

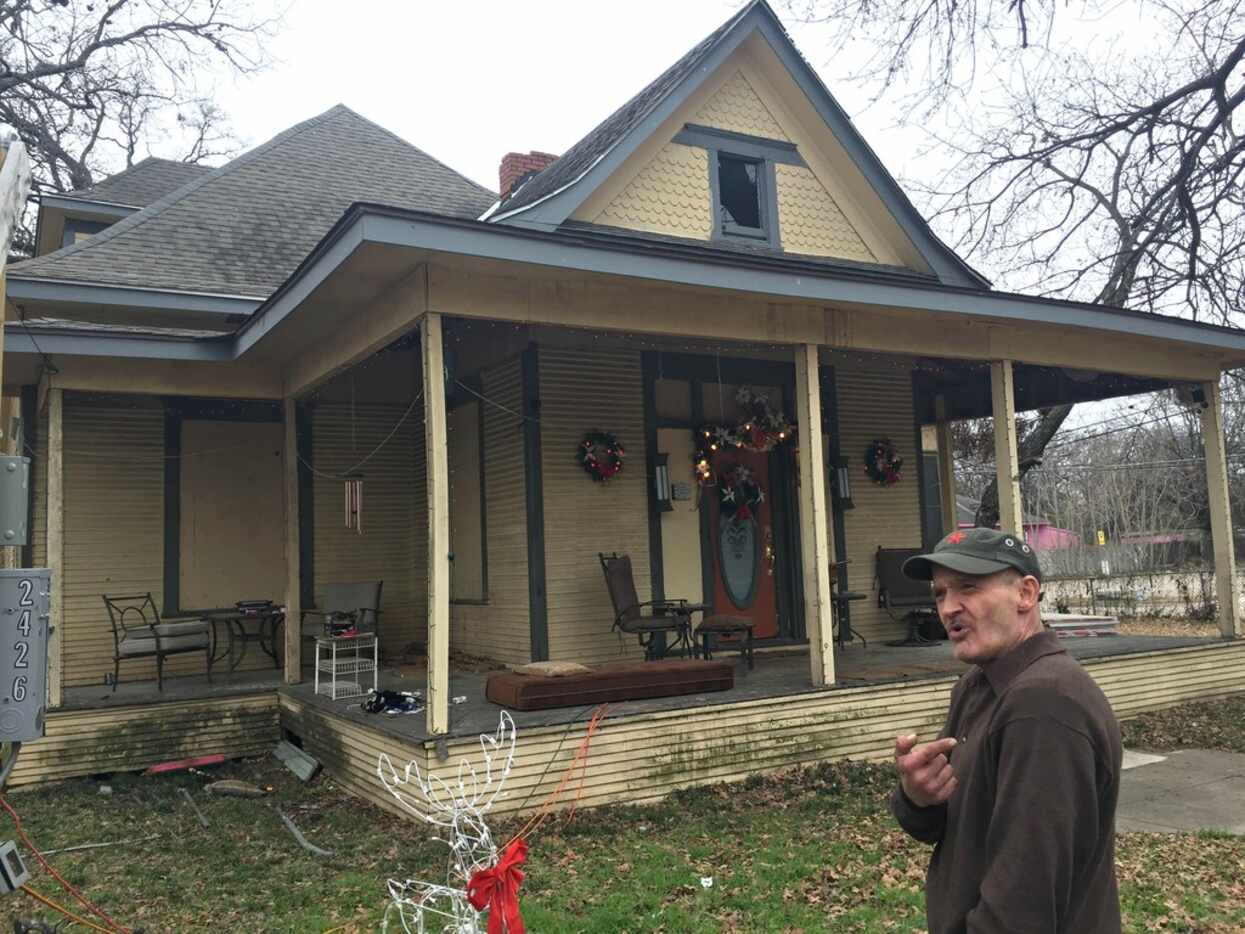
left=447, top=402, right=487, bottom=600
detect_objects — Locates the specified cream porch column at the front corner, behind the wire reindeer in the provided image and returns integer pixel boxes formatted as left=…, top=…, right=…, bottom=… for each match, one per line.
left=420, top=311, right=449, bottom=736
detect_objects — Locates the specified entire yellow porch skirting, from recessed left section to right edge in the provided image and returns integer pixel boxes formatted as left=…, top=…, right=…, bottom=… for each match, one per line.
left=9, top=640, right=1245, bottom=797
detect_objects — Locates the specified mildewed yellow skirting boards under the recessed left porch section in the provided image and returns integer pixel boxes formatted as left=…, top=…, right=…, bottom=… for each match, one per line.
left=6, top=689, right=279, bottom=787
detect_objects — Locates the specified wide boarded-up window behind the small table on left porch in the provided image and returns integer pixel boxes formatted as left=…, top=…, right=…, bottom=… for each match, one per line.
left=178, top=418, right=285, bottom=610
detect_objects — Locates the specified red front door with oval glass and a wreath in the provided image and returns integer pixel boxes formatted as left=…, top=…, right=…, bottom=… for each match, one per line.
left=705, top=450, right=778, bottom=639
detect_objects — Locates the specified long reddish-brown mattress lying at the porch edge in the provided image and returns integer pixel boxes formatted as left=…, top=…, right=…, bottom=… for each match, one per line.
left=484, top=659, right=735, bottom=710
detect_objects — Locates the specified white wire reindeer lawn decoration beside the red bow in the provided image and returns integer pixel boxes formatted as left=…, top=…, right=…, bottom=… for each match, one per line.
left=376, top=710, right=515, bottom=934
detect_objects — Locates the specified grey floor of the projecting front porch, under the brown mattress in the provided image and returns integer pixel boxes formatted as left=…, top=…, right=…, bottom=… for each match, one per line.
left=279, top=635, right=1220, bottom=742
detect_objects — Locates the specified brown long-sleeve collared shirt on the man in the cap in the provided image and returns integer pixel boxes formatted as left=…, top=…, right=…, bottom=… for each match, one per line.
left=891, top=631, right=1122, bottom=934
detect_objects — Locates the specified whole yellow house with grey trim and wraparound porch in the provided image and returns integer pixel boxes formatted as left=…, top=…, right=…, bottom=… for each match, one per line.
left=4, top=0, right=1245, bottom=806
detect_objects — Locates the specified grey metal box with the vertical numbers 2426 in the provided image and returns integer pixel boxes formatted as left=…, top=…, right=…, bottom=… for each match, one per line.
left=0, top=568, right=52, bottom=742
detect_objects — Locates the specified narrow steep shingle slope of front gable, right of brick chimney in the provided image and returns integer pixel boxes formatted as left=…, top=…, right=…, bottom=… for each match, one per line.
left=498, top=4, right=753, bottom=214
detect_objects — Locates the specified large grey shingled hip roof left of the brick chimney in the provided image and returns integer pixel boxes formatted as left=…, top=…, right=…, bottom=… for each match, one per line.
left=10, top=105, right=497, bottom=298
